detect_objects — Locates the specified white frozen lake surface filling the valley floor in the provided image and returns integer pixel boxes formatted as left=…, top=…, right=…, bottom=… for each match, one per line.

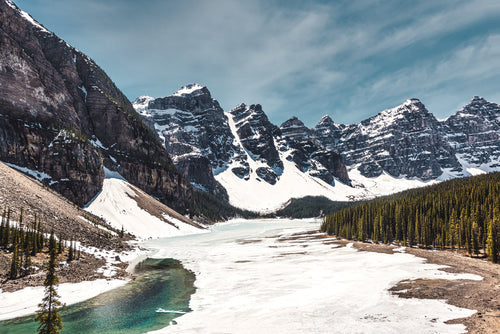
left=145, top=220, right=481, bottom=333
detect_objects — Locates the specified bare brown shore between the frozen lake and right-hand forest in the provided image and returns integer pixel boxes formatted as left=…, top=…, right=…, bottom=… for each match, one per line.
left=337, top=239, right=500, bottom=334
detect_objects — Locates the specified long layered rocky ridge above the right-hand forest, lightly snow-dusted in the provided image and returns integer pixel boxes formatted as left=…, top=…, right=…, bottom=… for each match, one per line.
left=312, top=96, right=500, bottom=181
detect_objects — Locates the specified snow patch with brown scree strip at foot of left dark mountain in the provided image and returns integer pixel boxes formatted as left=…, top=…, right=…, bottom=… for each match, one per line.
left=85, top=171, right=203, bottom=239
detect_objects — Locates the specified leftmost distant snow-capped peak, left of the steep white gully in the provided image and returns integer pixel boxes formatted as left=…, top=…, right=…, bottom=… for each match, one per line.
left=133, top=84, right=235, bottom=199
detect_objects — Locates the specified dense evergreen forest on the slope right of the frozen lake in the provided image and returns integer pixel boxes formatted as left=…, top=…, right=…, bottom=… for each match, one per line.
left=321, top=173, right=500, bottom=263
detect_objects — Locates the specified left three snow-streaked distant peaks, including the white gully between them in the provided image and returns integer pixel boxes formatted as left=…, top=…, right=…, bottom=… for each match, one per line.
left=133, top=84, right=350, bottom=199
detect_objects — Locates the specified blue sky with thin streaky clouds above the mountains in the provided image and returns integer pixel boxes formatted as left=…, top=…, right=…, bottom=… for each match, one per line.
left=14, top=0, right=500, bottom=127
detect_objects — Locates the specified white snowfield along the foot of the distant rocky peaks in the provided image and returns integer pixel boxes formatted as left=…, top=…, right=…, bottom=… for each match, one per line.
left=215, top=115, right=436, bottom=212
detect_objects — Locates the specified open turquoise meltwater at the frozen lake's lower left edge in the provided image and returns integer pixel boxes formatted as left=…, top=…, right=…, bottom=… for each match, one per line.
left=0, top=259, right=195, bottom=334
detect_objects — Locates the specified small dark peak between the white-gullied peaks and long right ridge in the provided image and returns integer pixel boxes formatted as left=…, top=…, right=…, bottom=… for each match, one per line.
left=280, top=117, right=351, bottom=185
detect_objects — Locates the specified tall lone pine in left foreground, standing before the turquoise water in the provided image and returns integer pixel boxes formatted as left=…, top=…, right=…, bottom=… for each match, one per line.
left=35, top=232, right=63, bottom=334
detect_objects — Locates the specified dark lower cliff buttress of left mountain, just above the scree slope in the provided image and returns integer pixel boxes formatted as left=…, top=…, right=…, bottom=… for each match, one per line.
left=0, top=115, right=104, bottom=204
